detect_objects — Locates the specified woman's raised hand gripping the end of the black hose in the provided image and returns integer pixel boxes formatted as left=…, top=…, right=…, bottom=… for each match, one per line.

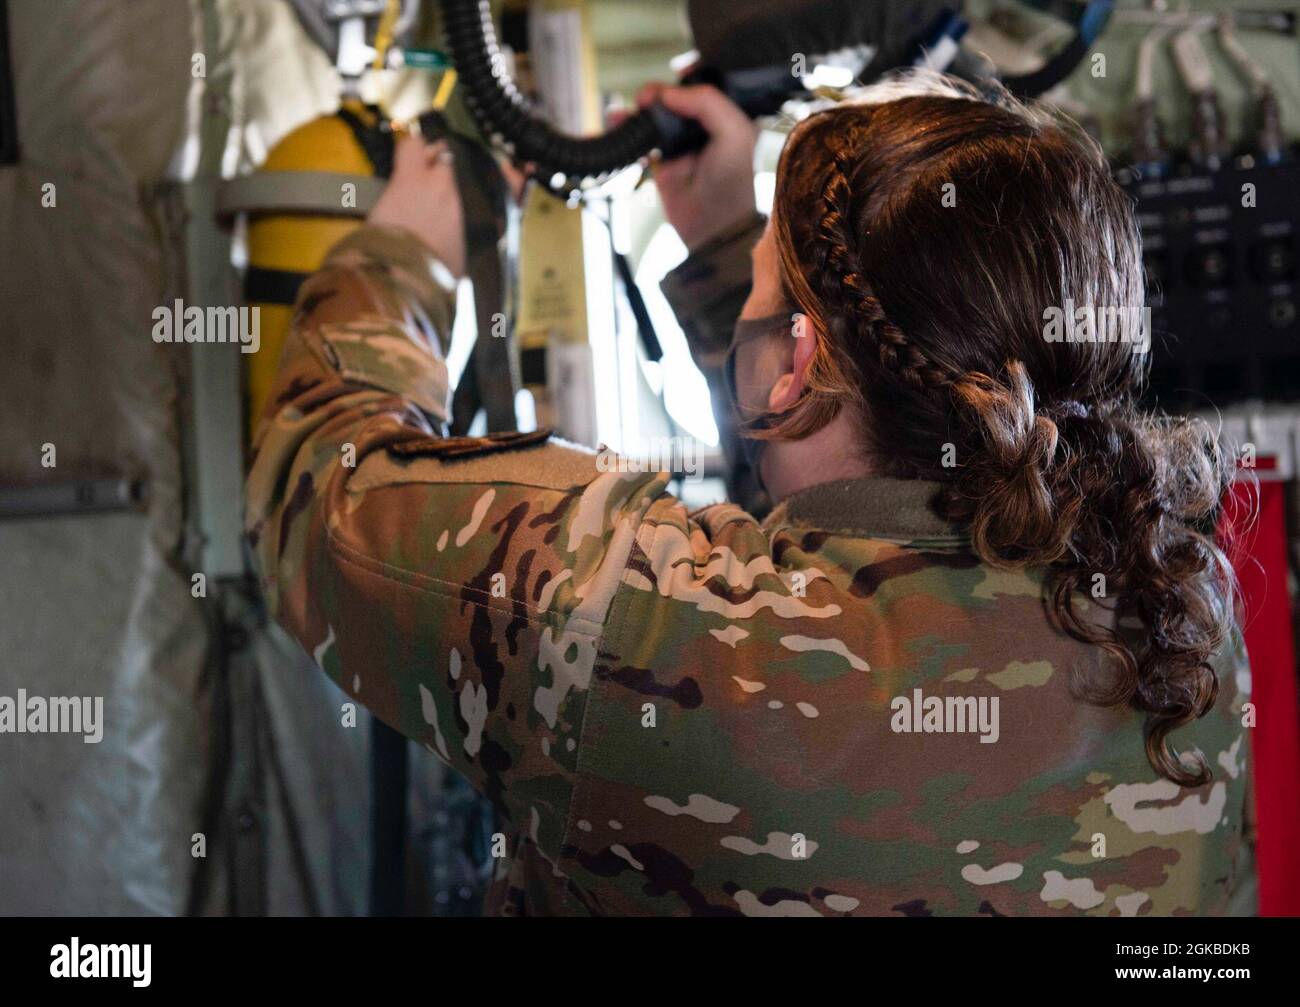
left=637, top=84, right=758, bottom=251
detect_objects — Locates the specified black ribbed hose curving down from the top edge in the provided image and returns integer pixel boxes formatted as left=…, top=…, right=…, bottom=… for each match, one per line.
left=442, top=0, right=663, bottom=179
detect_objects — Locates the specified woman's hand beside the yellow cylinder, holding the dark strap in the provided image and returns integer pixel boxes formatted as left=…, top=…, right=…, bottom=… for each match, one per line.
left=367, top=136, right=465, bottom=278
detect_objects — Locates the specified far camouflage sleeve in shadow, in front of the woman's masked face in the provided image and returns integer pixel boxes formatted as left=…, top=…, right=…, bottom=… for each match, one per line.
left=659, top=214, right=768, bottom=513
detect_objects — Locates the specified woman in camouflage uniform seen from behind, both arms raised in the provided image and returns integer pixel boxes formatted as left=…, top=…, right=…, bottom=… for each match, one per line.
left=247, top=74, right=1249, bottom=916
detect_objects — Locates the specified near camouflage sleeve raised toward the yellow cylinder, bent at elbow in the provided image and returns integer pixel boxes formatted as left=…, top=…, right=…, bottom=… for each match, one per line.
left=246, top=222, right=667, bottom=883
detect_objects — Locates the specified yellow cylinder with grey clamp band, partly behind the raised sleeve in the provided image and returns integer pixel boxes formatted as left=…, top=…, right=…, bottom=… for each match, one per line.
left=232, top=101, right=385, bottom=431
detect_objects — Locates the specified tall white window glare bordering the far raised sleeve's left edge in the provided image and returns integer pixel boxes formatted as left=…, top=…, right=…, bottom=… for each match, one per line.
left=637, top=223, right=718, bottom=444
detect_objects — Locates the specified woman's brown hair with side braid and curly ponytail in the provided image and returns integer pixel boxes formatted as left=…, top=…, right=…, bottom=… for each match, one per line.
left=755, top=76, right=1236, bottom=786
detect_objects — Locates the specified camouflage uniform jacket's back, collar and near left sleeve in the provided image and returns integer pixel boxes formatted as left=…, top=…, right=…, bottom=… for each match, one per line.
left=247, top=227, right=1248, bottom=916
